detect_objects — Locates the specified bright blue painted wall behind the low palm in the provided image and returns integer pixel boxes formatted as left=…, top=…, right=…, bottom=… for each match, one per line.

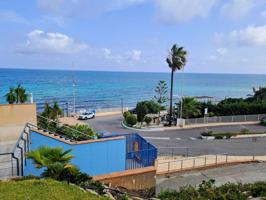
left=24, top=132, right=126, bottom=176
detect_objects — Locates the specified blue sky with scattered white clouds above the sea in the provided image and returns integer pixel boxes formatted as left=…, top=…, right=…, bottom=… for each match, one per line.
left=0, top=0, right=266, bottom=74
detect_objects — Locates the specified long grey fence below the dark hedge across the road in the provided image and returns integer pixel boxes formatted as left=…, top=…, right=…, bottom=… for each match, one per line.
left=185, top=114, right=266, bottom=125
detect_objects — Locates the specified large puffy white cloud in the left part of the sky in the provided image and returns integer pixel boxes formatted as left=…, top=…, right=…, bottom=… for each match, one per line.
left=17, top=30, right=88, bottom=54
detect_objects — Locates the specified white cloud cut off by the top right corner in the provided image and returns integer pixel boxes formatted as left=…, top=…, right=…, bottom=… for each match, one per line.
left=221, top=0, right=265, bottom=19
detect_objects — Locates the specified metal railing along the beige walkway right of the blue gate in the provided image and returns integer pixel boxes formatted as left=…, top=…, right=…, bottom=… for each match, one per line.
left=157, top=154, right=256, bottom=174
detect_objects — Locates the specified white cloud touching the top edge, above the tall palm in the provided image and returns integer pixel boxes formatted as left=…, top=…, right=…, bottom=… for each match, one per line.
left=155, top=0, right=217, bottom=23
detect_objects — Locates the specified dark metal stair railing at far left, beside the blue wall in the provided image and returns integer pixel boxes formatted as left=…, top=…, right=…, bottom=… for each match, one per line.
left=0, top=124, right=30, bottom=179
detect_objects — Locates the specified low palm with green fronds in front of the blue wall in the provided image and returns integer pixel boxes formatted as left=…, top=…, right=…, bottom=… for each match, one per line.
left=27, top=146, right=79, bottom=180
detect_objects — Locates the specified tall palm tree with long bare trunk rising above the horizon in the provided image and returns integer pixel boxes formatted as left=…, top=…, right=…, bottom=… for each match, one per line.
left=166, top=44, right=187, bottom=126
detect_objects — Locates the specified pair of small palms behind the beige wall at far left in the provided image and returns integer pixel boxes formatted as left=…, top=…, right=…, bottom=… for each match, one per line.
left=5, top=84, right=28, bottom=104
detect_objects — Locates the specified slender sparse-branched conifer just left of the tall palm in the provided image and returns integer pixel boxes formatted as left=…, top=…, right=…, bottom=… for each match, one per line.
left=154, top=80, right=168, bottom=120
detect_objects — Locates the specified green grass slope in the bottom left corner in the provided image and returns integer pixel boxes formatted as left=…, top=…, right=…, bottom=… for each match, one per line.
left=0, top=179, right=107, bottom=200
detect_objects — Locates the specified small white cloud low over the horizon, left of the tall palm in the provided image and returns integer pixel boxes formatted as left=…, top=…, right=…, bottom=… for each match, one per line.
left=102, top=48, right=142, bottom=63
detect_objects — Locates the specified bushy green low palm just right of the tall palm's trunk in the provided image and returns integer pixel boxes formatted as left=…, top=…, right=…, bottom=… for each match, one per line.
left=176, top=97, right=201, bottom=118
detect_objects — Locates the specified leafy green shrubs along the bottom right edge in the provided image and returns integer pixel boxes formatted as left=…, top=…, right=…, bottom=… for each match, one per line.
left=159, top=180, right=266, bottom=200
